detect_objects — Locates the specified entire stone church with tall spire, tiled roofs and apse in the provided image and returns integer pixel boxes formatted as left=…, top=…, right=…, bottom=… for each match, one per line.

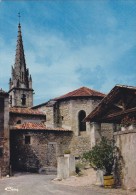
left=0, top=23, right=113, bottom=176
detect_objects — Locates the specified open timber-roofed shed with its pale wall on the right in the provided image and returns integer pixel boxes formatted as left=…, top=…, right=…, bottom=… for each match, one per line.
left=85, top=85, right=136, bottom=189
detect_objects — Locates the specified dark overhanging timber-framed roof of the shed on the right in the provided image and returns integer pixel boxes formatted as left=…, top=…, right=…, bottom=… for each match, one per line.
left=84, top=85, right=136, bottom=124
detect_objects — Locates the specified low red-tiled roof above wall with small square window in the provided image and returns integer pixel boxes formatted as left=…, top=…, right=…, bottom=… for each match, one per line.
left=11, top=122, right=71, bottom=131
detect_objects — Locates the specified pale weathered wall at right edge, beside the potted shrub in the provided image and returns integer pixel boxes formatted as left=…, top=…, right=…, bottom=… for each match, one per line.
left=114, top=127, right=136, bottom=189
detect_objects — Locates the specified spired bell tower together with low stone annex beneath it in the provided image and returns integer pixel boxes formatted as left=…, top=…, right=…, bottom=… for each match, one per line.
left=9, top=23, right=72, bottom=171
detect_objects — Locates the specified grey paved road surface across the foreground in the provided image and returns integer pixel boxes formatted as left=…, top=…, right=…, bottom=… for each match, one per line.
left=0, top=174, right=136, bottom=195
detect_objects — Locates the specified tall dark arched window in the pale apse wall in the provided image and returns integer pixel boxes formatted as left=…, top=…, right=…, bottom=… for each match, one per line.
left=78, top=110, right=86, bottom=131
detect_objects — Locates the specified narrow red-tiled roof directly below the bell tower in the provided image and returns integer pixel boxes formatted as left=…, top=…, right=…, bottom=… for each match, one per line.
left=10, top=107, right=45, bottom=115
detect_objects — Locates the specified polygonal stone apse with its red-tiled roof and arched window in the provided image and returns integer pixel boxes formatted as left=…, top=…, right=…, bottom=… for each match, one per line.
left=33, top=87, right=104, bottom=157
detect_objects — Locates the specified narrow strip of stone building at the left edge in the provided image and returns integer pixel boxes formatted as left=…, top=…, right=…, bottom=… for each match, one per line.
left=0, top=90, right=10, bottom=177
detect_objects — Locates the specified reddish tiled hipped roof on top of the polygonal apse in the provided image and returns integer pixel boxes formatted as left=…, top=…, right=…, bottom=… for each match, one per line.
left=54, top=87, right=105, bottom=100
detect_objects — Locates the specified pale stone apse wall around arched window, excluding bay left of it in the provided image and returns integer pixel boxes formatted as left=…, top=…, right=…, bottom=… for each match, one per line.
left=55, top=98, right=100, bottom=157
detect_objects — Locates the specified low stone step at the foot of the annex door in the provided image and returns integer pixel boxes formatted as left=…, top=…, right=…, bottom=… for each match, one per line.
left=38, top=167, right=57, bottom=175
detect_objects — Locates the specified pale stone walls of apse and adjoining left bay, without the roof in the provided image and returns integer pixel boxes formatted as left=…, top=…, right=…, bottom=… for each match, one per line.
left=33, top=98, right=100, bottom=156
